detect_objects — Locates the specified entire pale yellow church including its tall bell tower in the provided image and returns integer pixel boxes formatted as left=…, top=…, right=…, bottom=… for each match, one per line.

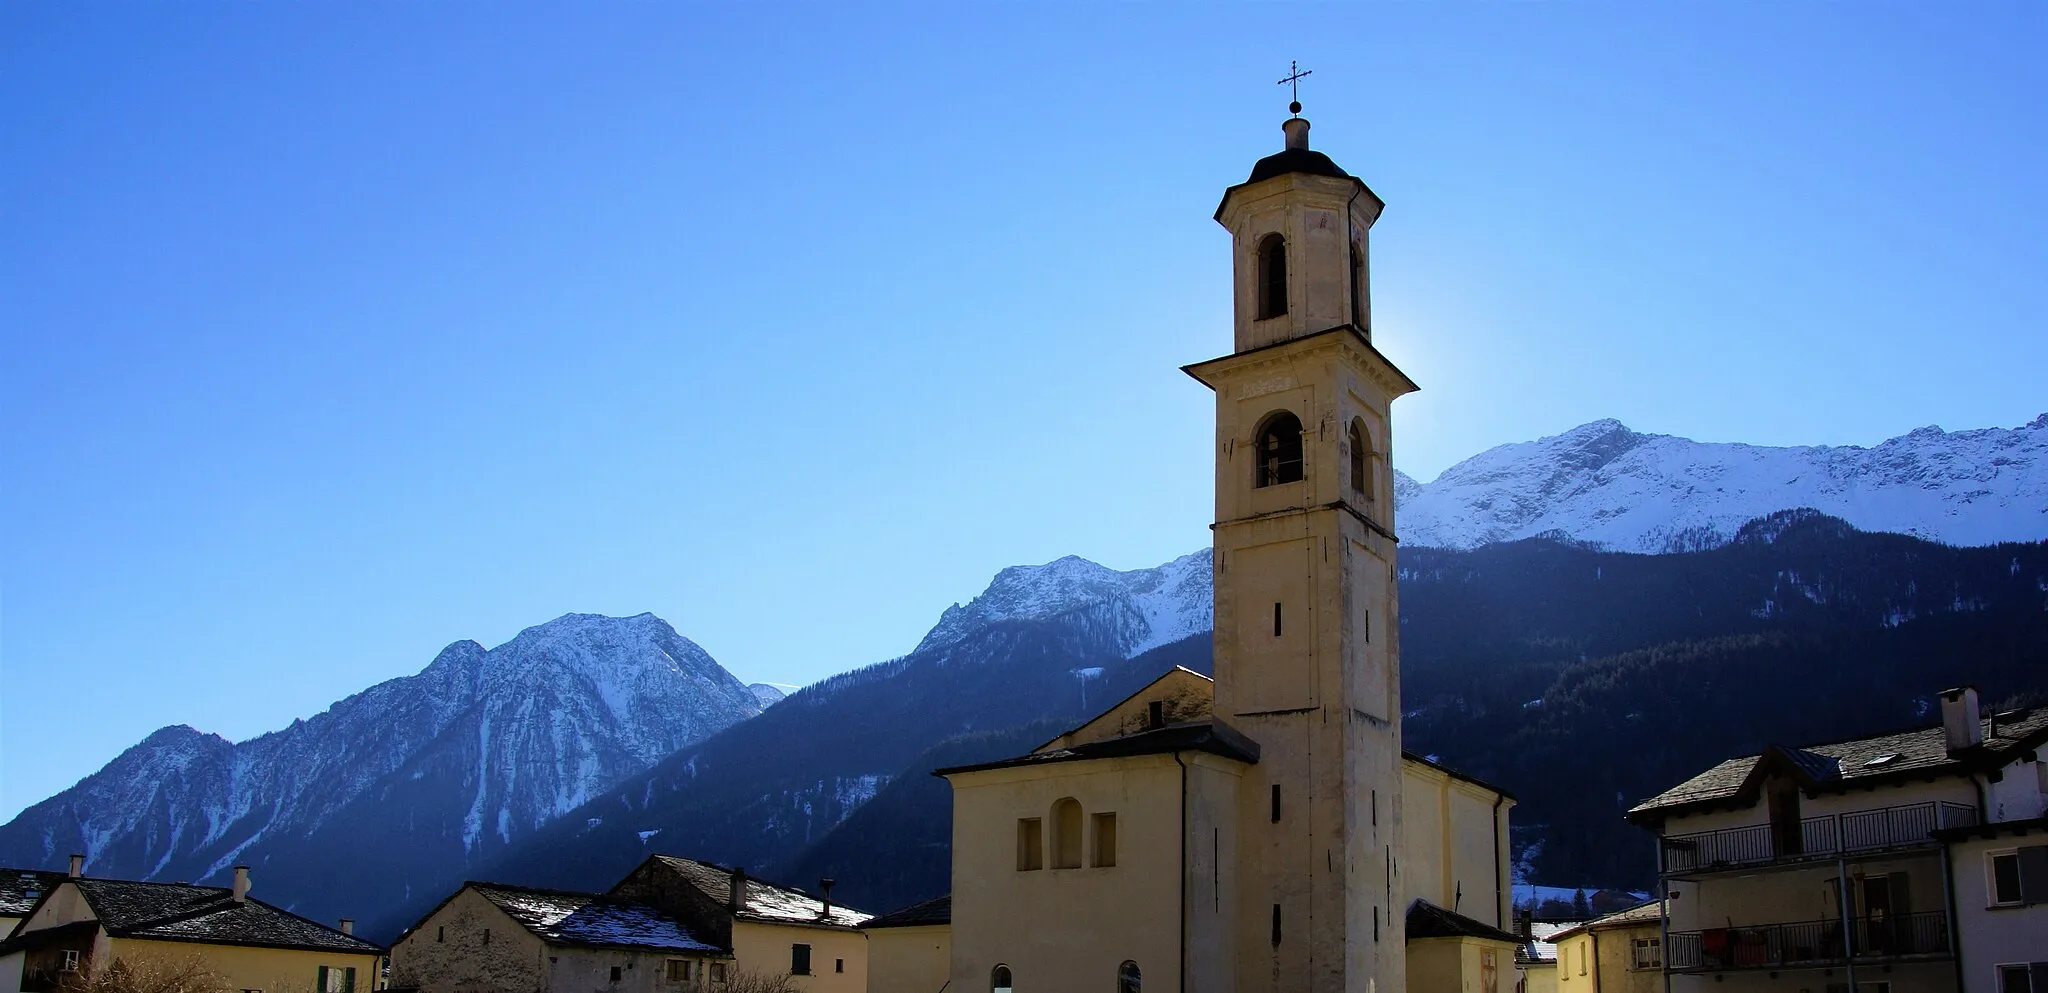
left=905, top=104, right=1518, bottom=993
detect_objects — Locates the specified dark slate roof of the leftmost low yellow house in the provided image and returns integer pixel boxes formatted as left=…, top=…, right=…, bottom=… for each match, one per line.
left=46, top=878, right=383, bottom=954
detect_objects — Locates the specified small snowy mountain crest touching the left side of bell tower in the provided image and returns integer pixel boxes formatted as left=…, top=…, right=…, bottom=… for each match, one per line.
left=918, top=549, right=1212, bottom=657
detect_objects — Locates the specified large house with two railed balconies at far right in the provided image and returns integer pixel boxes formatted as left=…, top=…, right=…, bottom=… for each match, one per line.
left=1622, top=688, right=2048, bottom=993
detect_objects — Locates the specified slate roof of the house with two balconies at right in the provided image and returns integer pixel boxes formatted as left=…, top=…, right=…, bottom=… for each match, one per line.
left=1628, top=706, right=2048, bottom=823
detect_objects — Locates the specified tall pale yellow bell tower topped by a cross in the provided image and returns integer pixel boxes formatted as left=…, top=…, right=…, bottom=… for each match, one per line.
left=1186, top=104, right=1417, bottom=993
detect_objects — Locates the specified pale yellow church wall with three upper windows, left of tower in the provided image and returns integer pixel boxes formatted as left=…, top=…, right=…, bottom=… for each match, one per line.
left=950, top=753, right=1237, bottom=993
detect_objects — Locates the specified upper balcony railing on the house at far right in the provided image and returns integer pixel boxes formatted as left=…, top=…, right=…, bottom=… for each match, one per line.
left=1663, top=801, right=1976, bottom=874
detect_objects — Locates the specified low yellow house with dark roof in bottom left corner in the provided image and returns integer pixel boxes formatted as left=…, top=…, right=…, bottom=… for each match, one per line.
left=0, top=856, right=383, bottom=993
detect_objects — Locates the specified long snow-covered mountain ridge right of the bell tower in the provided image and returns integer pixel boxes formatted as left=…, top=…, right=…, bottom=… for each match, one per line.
left=1395, top=414, right=2048, bottom=553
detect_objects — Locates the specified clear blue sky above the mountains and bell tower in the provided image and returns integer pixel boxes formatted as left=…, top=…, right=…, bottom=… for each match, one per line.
left=0, top=0, right=2048, bottom=817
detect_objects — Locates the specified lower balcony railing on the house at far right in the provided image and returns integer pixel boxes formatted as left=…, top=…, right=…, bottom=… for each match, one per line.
left=1665, top=911, right=1954, bottom=973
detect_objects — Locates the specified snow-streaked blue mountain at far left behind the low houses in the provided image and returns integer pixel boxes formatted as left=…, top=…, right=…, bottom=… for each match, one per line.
left=0, top=614, right=760, bottom=917
